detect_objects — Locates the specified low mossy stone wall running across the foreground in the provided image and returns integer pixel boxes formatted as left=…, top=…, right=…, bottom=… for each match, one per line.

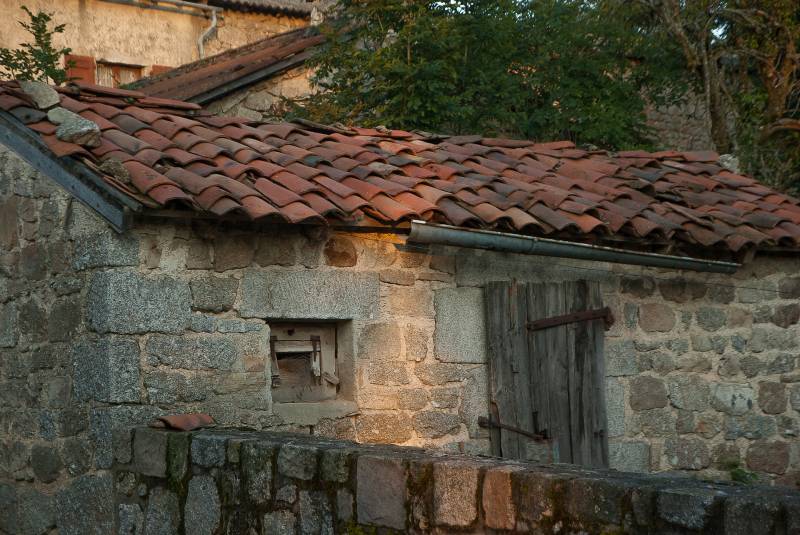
left=112, top=428, right=800, bottom=535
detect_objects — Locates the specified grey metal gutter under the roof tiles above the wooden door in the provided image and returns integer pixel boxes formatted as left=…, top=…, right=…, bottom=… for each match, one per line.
left=407, top=221, right=741, bottom=274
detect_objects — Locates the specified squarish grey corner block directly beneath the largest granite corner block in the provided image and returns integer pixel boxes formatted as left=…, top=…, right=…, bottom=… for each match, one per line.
left=72, top=336, right=140, bottom=403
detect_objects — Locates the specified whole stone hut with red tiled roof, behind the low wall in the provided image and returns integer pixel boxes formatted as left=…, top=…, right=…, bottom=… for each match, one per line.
left=0, top=82, right=800, bottom=533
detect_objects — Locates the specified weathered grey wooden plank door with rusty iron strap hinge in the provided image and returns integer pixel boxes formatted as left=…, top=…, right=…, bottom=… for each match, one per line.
left=485, top=281, right=608, bottom=467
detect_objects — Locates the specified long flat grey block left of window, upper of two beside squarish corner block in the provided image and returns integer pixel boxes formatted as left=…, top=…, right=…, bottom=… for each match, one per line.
left=146, top=334, right=238, bottom=370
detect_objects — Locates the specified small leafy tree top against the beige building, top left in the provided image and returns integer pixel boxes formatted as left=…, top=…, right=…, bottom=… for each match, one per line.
left=0, top=6, right=70, bottom=85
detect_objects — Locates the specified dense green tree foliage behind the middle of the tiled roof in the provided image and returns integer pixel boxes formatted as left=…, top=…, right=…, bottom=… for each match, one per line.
left=300, top=0, right=684, bottom=148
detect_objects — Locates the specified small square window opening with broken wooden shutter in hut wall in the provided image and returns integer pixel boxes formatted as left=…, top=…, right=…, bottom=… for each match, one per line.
left=269, top=324, right=339, bottom=403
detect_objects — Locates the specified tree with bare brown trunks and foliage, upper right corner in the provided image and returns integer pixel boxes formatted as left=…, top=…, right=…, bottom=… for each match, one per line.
left=636, top=0, right=800, bottom=193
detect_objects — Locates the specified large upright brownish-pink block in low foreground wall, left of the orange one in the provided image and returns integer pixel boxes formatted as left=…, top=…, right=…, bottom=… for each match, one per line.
left=356, top=456, right=407, bottom=531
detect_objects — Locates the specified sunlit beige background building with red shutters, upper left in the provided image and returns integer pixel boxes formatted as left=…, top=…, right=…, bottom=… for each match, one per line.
left=0, top=0, right=313, bottom=87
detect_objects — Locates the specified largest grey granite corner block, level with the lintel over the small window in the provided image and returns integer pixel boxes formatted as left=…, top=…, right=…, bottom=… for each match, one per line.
left=88, top=271, right=191, bottom=334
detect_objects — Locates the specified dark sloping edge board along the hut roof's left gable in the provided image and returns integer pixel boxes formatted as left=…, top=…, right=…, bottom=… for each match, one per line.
left=0, top=110, right=142, bottom=232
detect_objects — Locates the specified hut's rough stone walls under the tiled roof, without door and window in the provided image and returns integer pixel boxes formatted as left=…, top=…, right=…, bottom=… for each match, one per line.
left=7, top=136, right=800, bottom=533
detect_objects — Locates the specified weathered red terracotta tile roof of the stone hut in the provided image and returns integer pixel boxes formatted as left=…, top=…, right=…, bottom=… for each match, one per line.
left=0, top=82, right=800, bottom=258
